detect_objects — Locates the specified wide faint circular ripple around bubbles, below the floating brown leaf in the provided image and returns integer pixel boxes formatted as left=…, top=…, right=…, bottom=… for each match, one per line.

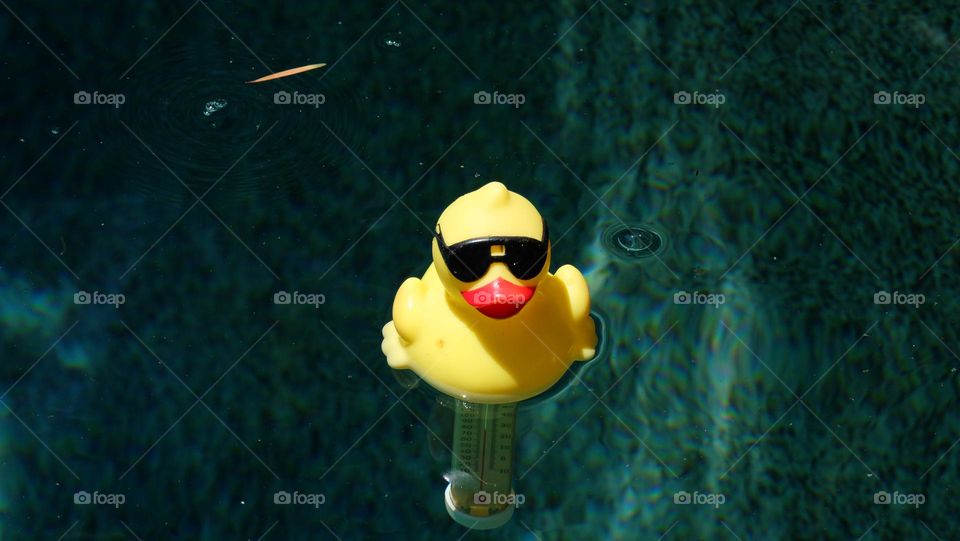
left=111, top=47, right=358, bottom=204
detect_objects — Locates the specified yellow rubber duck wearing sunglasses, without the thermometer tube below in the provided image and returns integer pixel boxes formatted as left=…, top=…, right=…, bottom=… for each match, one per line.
left=381, top=182, right=597, bottom=404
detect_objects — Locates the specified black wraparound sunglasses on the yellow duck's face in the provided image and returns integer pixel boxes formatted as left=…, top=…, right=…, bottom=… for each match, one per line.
left=434, top=220, right=550, bottom=282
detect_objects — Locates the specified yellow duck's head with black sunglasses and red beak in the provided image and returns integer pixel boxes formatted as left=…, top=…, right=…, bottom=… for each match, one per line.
left=433, top=182, right=550, bottom=319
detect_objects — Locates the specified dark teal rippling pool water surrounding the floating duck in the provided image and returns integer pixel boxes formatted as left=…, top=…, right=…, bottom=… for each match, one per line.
left=0, top=1, right=960, bottom=540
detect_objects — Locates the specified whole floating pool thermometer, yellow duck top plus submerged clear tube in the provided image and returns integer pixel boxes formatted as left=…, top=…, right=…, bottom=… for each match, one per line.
left=382, top=182, right=597, bottom=529
